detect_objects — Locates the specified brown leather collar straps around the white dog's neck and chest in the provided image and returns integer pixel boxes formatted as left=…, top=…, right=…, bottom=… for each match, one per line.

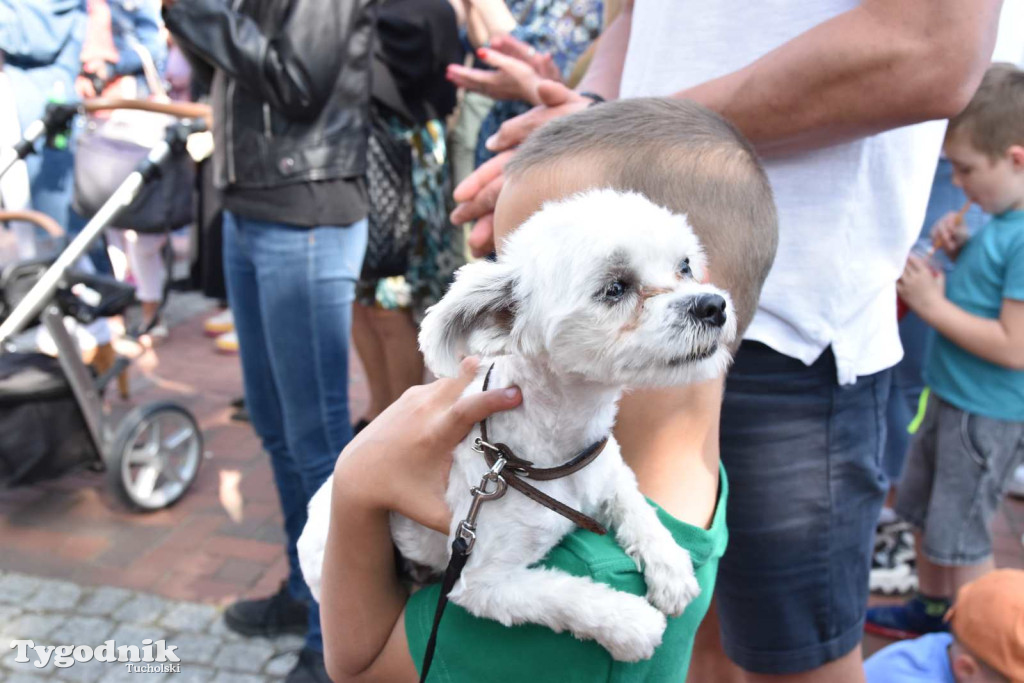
left=475, top=364, right=608, bottom=535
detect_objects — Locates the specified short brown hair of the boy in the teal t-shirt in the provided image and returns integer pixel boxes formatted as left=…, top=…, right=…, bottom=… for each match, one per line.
left=946, top=62, right=1024, bottom=160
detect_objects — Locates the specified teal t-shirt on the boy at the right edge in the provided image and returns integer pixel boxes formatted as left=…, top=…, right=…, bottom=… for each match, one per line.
left=925, top=211, right=1024, bottom=421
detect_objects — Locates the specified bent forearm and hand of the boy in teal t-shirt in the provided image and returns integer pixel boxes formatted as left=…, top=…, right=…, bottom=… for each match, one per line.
left=896, top=256, right=1024, bottom=370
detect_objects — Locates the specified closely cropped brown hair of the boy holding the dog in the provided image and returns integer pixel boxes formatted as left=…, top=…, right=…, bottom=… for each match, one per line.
left=505, top=97, right=778, bottom=343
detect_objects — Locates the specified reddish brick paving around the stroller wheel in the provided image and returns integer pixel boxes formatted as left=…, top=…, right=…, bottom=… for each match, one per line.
left=0, top=294, right=366, bottom=605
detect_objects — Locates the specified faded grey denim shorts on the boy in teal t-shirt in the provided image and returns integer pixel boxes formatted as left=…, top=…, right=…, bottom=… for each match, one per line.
left=896, top=392, right=1024, bottom=566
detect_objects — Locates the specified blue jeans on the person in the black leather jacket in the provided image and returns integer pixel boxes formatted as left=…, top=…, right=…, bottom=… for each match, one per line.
left=223, top=212, right=367, bottom=651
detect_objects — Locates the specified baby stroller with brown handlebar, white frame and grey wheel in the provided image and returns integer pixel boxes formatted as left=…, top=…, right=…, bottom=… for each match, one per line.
left=0, top=100, right=209, bottom=510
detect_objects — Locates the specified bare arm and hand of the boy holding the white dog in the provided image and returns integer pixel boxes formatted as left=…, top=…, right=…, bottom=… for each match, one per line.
left=321, top=360, right=521, bottom=683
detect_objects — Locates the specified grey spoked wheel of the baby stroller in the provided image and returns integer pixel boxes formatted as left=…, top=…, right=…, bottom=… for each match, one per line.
left=108, top=401, right=203, bottom=510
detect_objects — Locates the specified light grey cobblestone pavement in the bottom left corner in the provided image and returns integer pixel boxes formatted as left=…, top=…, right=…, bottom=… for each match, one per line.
left=0, top=571, right=302, bottom=683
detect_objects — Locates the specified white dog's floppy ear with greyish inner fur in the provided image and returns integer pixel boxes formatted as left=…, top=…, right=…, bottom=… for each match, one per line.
left=420, top=261, right=517, bottom=377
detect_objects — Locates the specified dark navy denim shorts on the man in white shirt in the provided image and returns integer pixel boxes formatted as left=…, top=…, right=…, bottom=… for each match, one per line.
left=716, top=342, right=891, bottom=675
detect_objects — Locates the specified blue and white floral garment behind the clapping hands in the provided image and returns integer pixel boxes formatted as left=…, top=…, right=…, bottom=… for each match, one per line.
left=476, top=0, right=604, bottom=166
